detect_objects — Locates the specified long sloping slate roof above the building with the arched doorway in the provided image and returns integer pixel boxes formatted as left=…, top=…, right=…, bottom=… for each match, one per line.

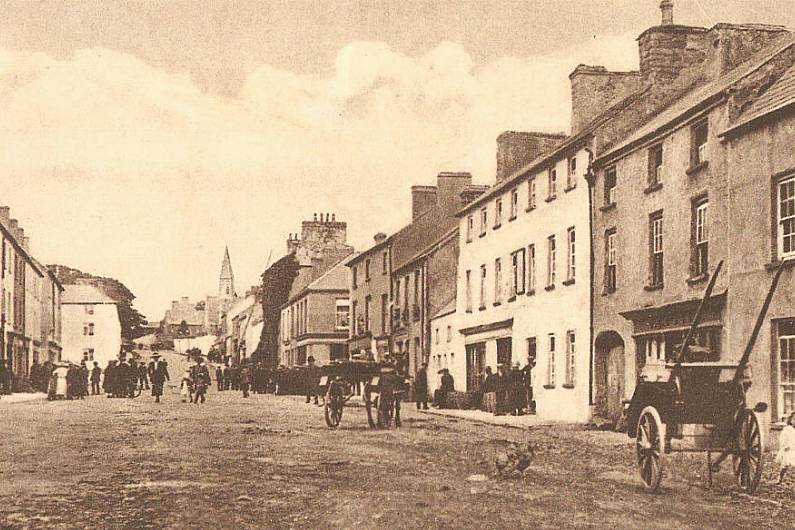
left=597, top=35, right=795, bottom=161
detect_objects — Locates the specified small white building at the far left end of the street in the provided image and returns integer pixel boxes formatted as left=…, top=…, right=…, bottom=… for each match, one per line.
left=61, top=285, right=121, bottom=367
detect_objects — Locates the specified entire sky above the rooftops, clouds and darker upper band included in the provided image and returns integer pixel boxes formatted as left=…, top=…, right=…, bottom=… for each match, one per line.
left=0, top=0, right=795, bottom=320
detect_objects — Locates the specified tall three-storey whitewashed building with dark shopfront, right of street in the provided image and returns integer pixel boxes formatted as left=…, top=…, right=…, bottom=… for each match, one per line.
left=458, top=133, right=592, bottom=422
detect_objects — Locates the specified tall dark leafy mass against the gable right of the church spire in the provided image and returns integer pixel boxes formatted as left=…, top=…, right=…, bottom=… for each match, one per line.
left=253, top=254, right=298, bottom=367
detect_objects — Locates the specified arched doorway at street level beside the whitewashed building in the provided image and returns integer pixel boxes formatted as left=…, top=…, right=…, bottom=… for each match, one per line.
left=594, top=331, right=625, bottom=423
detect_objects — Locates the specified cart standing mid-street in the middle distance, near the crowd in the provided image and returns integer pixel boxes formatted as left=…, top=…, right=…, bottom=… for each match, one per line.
left=320, top=361, right=408, bottom=429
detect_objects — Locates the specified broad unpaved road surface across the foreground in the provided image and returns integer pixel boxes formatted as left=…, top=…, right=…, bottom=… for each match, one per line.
left=0, top=369, right=795, bottom=529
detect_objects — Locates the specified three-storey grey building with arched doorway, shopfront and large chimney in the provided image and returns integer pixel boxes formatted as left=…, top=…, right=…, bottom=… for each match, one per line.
left=590, top=2, right=795, bottom=420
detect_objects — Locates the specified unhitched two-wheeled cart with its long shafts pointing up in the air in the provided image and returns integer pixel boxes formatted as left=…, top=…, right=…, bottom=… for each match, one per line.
left=626, top=262, right=782, bottom=494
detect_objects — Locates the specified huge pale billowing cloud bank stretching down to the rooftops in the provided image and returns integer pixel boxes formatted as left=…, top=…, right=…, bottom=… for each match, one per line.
left=0, top=36, right=637, bottom=318
